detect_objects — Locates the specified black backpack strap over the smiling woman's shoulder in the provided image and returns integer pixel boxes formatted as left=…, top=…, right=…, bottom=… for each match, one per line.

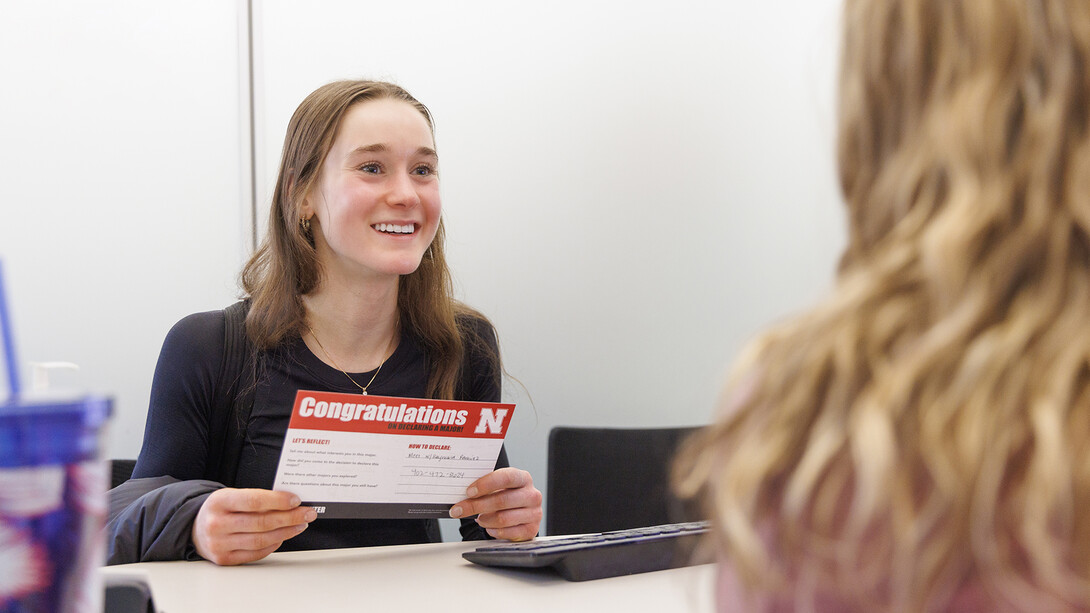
left=205, top=300, right=257, bottom=486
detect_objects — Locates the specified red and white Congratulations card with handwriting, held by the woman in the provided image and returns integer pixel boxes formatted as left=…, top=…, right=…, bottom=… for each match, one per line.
left=273, top=390, right=514, bottom=518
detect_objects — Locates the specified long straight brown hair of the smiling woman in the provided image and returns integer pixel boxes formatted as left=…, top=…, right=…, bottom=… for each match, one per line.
left=241, top=81, right=499, bottom=398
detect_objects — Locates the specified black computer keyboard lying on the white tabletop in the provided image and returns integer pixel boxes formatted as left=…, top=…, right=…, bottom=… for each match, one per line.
left=462, top=521, right=709, bottom=581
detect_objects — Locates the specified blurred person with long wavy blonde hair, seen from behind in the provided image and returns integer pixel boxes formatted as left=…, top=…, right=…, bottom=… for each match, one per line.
left=675, top=0, right=1090, bottom=611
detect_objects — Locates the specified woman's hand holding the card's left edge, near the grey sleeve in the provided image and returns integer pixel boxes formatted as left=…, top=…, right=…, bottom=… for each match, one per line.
left=192, top=488, right=318, bottom=565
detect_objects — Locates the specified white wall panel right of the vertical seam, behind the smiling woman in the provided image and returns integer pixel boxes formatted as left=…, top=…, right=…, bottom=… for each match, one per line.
left=256, top=0, right=843, bottom=532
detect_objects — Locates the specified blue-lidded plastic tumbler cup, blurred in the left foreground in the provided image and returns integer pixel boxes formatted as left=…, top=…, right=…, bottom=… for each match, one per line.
left=0, top=396, right=112, bottom=613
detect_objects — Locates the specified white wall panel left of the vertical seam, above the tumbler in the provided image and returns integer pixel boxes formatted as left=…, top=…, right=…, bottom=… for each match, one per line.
left=0, top=0, right=251, bottom=457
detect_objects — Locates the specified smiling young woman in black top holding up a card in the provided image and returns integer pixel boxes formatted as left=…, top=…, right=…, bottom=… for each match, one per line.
left=109, top=81, right=542, bottom=564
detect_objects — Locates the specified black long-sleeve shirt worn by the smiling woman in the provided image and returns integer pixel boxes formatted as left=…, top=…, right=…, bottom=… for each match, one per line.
left=109, top=311, right=508, bottom=563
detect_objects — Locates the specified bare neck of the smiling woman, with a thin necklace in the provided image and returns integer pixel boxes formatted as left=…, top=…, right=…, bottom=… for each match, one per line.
left=303, top=278, right=399, bottom=372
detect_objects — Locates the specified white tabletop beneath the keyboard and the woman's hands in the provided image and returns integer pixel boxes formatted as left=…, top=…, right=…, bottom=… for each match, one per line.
left=102, top=542, right=714, bottom=613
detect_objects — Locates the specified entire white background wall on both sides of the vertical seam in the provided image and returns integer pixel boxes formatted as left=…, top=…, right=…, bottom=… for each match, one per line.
left=0, top=0, right=843, bottom=534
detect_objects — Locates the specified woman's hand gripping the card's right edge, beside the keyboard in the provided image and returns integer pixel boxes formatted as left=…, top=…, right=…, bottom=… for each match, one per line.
left=450, top=468, right=542, bottom=541
